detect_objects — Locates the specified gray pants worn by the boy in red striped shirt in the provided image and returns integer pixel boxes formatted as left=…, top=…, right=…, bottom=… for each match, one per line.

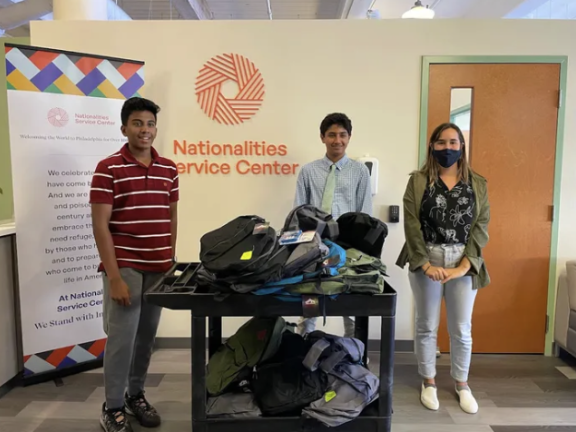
left=103, top=268, right=163, bottom=408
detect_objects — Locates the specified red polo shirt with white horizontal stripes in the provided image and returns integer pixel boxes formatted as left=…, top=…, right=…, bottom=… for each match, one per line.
left=90, top=144, right=179, bottom=272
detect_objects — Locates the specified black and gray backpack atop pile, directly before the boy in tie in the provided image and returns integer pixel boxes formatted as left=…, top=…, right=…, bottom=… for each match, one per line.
left=282, top=204, right=338, bottom=241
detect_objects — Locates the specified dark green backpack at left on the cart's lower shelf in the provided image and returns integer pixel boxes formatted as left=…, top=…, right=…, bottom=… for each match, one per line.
left=206, top=317, right=288, bottom=396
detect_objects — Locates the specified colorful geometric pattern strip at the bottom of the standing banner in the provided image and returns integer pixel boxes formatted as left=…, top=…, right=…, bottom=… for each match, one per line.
left=24, top=339, right=106, bottom=377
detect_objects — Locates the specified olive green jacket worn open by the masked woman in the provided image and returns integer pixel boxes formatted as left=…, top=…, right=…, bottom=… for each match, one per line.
left=396, top=171, right=490, bottom=289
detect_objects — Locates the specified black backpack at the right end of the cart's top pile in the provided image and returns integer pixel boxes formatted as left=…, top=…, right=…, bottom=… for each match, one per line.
left=336, top=212, right=388, bottom=258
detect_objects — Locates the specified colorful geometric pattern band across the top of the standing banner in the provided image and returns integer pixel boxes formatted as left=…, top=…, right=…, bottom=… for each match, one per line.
left=5, top=46, right=144, bottom=99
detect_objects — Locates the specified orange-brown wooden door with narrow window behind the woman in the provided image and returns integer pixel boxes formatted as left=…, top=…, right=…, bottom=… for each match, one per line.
left=428, top=64, right=560, bottom=353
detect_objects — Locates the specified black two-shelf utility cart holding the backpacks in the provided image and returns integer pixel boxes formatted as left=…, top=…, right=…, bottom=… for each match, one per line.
left=146, top=263, right=396, bottom=432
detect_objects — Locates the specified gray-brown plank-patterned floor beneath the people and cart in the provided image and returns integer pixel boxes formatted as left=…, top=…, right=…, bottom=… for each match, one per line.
left=0, top=350, right=576, bottom=432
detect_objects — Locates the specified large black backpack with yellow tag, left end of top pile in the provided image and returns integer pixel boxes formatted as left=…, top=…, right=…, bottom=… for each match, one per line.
left=198, top=216, right=290, bottom=292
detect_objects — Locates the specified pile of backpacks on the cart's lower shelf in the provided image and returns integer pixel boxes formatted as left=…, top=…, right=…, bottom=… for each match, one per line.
left=206, top=317, right=380, bottom=427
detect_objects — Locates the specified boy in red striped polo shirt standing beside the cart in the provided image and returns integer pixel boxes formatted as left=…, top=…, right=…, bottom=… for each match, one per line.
left=90, top=98, right=179, bottom=432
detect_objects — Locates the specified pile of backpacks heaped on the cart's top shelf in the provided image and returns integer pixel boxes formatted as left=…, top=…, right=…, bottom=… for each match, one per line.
left=195, top=205, right=388, bottom=300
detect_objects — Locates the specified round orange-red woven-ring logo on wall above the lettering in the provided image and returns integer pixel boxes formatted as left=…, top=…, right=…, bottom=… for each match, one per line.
left=196, top=54, right=264, bottom=125
